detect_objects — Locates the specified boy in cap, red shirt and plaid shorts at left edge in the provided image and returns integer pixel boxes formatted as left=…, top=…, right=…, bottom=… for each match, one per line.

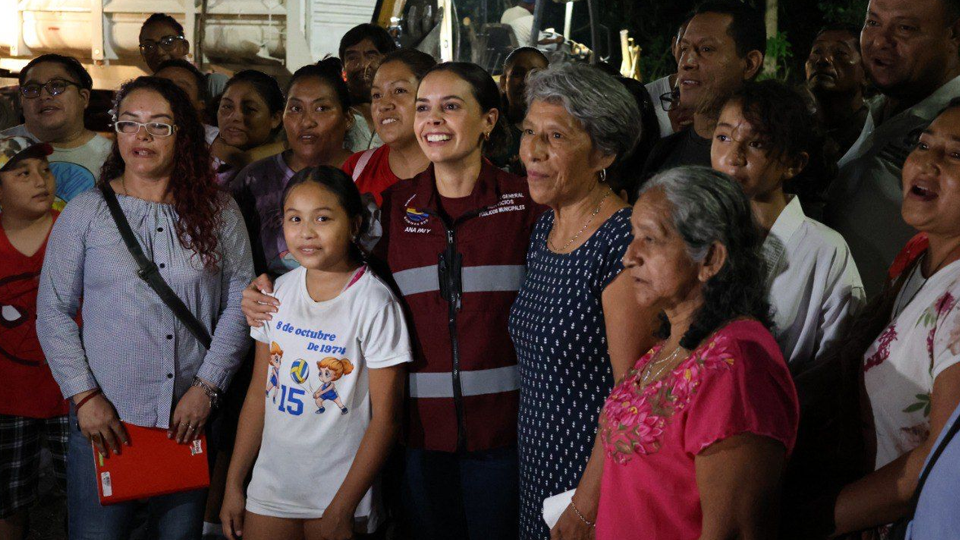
left=0, top=137, right=68, bottom=540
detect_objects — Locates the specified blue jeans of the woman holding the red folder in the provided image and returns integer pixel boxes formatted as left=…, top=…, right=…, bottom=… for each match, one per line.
left=67, top=414, right=207, bottom=540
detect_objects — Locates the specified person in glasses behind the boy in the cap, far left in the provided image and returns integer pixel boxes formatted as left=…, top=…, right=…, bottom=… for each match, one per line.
left=2, top=54, right=113, bottom=210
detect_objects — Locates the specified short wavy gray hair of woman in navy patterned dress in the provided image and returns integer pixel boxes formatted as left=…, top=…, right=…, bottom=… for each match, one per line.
left=526, top=62, right=640, bottom=160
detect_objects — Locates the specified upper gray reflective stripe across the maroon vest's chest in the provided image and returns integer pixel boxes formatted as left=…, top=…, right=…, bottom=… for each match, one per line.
left=393, top=264, right=527, bottom=296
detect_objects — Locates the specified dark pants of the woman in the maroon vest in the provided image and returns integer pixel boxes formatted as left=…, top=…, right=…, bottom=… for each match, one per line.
left=401, top=446, right=520, bottom=540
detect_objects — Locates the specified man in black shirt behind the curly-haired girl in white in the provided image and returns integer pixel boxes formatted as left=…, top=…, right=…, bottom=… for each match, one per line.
left=643, top=0, right=767, bottom=178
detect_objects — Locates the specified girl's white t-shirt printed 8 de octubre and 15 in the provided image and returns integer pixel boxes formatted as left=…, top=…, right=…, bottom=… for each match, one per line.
left=247, top=267, right=413, bottom=532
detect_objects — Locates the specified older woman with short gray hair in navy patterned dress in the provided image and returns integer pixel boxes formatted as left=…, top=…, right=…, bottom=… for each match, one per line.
left=509, top=64, right=656, bottom=540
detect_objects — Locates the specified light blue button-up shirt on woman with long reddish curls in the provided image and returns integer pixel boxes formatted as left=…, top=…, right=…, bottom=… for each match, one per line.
left=37, top=190, right=253, bottom=428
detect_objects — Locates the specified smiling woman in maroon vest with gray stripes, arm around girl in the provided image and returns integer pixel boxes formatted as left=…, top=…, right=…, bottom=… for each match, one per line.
left=244, top=62, right=545, bottom=540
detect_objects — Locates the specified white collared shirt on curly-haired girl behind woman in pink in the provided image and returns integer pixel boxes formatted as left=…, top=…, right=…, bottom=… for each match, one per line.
left=763, top=196, right=865, bottom=373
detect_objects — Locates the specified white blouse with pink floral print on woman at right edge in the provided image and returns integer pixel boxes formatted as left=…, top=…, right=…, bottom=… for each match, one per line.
left=863, top=261, right=960, bottom=469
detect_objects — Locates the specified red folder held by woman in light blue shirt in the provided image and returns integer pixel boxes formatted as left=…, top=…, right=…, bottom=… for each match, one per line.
left=93, top=422, right=210, bottom=505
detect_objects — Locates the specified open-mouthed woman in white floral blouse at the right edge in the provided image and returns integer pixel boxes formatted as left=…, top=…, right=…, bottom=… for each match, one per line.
left=824, top=100, right=960, bottom=534
